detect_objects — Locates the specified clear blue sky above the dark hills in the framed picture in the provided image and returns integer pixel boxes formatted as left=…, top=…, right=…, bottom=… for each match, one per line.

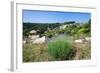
left=22, top=10, right=91, bottom=23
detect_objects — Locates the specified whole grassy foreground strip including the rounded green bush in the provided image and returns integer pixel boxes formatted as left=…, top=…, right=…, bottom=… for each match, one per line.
left=23, top=35, right=91, bottom=62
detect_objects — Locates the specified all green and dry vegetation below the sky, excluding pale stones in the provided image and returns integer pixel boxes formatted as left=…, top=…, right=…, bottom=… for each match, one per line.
left=23, top=20, right=91, bottom=62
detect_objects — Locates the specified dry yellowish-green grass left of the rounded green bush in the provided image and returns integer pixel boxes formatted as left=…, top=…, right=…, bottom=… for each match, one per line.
left=23, top=43, right=53, bottom=62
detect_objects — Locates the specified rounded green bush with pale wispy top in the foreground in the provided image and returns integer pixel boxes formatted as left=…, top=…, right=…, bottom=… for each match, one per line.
left=48, top=35, right=74, bottom=60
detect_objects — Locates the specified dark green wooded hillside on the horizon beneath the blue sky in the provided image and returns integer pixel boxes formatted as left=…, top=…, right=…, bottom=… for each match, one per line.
left=23, top=21, right=75, bottom=36
